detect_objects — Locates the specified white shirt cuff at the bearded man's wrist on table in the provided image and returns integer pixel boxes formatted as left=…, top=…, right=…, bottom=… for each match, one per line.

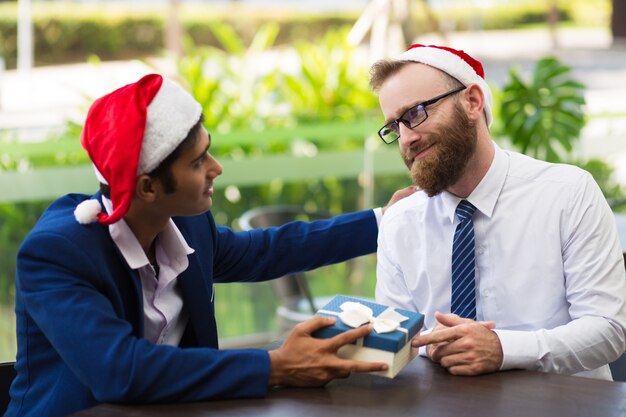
left=493, top=329, right=539, bottom=371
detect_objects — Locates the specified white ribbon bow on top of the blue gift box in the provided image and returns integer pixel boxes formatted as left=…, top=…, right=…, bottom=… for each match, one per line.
left=339, top=301, right=409, bottom=333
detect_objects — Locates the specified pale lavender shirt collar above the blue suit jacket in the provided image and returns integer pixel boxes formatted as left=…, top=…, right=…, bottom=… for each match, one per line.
left=102, top=196, right=194, bottom=269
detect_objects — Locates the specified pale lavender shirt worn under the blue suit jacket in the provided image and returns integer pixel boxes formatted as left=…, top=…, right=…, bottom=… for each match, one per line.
left=102, top=197, right=194, bottom=346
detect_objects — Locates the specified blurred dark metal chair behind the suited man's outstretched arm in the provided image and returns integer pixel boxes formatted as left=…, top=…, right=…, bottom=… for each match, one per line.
left=239, top=205, right=330, bottom=333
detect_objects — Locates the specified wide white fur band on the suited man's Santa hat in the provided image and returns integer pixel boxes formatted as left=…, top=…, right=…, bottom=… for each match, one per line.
left=137, top=78, right=202, bottom=174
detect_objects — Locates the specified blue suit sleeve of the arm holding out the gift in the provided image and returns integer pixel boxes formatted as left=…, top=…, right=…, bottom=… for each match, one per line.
left=17, top=232, right=270, bottom=403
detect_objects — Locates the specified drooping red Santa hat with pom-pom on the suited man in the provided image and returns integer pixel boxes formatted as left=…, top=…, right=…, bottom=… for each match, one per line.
left=74, top=74, right=202, bottom=225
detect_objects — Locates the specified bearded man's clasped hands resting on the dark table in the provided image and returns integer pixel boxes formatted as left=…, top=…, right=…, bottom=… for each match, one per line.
left=415, top=313, right=503, bottom=375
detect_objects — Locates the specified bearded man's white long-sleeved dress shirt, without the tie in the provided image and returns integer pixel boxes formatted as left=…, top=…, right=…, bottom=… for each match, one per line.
left=376, top=143, right=626, bottom=379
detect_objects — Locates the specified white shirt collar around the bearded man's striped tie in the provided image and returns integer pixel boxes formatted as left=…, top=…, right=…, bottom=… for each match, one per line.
left=441, top=141, right=509, bottom=223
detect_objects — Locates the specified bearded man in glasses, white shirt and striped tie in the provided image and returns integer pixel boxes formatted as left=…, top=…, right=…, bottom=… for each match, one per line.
left=371, top=45, right=626, bottom=380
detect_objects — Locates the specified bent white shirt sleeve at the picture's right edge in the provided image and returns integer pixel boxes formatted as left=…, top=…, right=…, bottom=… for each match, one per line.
left=495, top=174, right=626, bottom=374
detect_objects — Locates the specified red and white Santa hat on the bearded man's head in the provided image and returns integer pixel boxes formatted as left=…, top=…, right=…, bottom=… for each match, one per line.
left=396, top=43, right=493, bottom=126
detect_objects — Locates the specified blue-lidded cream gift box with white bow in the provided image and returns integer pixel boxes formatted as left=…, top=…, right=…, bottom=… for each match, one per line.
left=313, top=295, right=424, bottom=378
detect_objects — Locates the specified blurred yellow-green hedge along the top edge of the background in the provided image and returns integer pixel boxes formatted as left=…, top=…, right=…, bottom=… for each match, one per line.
left=0, top=0, right=611, bottom=68
